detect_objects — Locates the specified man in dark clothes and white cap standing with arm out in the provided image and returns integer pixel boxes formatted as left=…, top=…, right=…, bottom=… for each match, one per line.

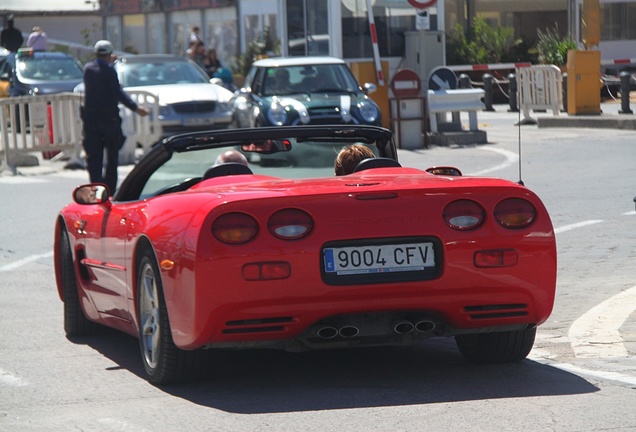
left=81, top=40, right=148, bottom=194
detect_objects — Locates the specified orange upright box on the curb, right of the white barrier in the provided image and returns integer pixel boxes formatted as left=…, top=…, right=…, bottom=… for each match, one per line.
left=567, top=50, right=601, bottom=115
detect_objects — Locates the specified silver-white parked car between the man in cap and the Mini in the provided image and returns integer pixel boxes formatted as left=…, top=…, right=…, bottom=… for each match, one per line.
left=115, top=54, right=233, bottom=135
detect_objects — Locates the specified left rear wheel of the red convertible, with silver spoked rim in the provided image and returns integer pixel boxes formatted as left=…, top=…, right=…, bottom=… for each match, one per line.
left=137, top=251, right=206, bottom=384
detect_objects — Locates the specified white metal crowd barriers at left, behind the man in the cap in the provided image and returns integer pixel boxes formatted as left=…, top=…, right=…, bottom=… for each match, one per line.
left=0, top=91, right=162, bottom=174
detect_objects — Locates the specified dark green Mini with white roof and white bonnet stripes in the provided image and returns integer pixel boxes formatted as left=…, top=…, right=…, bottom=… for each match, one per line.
left=232, top=57, right=382, bottom=128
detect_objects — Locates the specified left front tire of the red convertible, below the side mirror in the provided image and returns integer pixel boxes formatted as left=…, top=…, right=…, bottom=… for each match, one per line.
left=60, top=228, right=100, bottom=337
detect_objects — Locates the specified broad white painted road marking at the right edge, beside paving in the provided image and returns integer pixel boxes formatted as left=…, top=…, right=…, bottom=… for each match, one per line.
left=568, top=286, right=636, bottom=358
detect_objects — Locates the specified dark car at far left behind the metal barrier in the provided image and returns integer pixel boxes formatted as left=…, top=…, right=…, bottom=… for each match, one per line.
left=0, top=48, right=82, bottom=96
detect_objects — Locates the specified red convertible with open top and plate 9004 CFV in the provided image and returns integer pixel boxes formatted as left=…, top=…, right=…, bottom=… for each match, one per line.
left=54, top=126, right=556, bottom=384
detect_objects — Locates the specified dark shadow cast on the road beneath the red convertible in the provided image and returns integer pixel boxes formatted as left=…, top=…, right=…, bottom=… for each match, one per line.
left=76, top=332, right=598, bottom=414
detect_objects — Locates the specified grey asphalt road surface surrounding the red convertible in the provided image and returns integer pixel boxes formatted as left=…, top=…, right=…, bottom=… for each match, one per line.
left=0, top=107, right=636, bottom=432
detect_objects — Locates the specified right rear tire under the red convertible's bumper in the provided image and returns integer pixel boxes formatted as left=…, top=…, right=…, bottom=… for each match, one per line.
left=455, top=327, right=537, bottom=363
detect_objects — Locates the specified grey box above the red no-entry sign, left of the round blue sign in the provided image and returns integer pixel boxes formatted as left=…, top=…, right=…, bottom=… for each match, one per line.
left=404, top=30, right=446, bottom=93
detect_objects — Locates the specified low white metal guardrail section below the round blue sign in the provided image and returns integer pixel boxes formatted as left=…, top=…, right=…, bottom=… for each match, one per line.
left=428, top=89, right=486, bottom=133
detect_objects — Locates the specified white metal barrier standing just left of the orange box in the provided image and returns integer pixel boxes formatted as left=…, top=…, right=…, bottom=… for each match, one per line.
left=516, top=65, right=563, bottom=123
